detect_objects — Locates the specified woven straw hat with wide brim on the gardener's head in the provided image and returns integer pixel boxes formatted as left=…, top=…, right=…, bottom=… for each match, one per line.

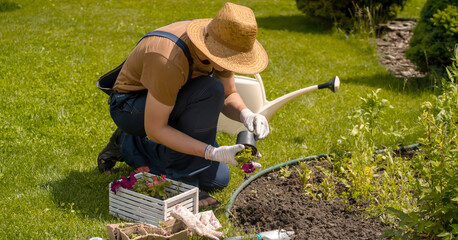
left=187, top=3, right=268, bottom=74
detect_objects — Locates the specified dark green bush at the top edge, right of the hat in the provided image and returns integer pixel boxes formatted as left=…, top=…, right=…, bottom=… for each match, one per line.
left=296, top=0, right=406, bottom=30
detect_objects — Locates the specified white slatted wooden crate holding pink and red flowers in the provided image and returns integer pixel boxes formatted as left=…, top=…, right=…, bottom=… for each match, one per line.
left=109, top=173, right=199, bottom=226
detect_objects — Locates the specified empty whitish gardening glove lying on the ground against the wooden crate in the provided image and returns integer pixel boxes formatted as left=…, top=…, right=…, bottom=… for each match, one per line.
left=170, top=204, right=223, bottom=240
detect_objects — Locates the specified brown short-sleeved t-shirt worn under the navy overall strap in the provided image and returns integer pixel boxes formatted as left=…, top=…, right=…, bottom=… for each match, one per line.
left=113, top=21, right=212, bottom=106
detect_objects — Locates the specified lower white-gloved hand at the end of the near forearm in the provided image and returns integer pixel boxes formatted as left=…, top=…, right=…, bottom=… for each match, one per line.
left=205, top=144, right=245, bottom=166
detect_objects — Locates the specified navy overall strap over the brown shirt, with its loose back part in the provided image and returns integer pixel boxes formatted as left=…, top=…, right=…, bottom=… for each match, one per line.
left=97, top=30, right=194, bottom=95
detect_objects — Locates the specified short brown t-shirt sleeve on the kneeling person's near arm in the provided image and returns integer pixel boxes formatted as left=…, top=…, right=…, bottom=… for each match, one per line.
left=140, top=52, right=186, bottom=106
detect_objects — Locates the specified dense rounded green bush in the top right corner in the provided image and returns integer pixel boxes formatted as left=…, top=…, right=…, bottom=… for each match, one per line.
left=406, top=0, right=458, bottom=72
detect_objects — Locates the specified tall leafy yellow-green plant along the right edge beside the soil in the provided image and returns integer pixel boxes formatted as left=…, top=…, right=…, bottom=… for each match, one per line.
left=387, top=50, right=458, bottom=239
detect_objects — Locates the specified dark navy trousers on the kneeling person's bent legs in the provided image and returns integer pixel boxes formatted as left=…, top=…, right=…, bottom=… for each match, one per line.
left=110, top=76, right=230, bottom=191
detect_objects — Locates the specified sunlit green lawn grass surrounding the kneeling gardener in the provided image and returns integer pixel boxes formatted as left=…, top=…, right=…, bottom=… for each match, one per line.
left=0, top=0, right=432, bottom=239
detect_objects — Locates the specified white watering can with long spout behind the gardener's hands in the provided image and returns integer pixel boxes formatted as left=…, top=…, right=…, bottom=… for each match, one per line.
left=218, top=74, right=340, bottom=134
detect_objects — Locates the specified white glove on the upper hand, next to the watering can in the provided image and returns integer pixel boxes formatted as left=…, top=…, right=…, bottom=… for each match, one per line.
left=240, top=108, right=269, bottom=140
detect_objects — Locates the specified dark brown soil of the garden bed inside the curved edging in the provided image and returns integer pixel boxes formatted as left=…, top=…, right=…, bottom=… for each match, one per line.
left=231, top=158, right=387, bottom=240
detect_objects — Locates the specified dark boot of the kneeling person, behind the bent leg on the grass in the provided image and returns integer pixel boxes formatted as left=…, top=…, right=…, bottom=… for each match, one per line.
left=97, top=128, right=122, bottom=174
